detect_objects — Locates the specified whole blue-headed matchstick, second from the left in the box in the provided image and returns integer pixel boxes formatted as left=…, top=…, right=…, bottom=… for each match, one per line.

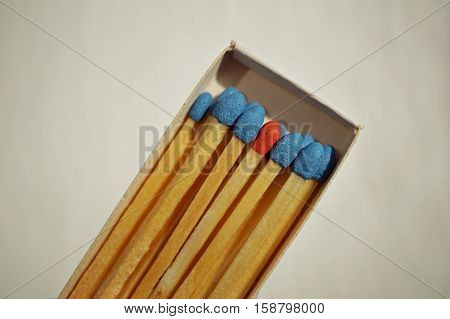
left=94, top=89, right=246, bottom=298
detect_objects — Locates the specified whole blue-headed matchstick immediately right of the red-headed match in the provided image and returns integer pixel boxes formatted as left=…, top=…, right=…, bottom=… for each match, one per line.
left=173, top=133, right=309, bottom=299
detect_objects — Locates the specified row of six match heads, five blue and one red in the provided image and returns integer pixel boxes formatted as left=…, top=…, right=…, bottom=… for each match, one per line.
left=189, top=87, right=336, bottom=181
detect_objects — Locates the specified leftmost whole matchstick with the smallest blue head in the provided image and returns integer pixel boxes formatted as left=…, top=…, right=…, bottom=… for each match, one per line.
left=69, top=92, right=212, bottom=298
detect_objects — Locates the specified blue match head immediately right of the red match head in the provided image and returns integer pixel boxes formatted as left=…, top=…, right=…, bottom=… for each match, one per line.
left=270, top=133, right=312, bottom=168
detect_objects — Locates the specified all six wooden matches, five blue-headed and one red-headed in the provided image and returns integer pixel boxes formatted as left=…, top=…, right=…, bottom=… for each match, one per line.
left=69, top=87, right=333, bottom=298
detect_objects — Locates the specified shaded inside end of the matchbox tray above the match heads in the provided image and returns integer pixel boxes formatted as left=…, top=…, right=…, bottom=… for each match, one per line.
left=205, top=51, right=356, bottom=162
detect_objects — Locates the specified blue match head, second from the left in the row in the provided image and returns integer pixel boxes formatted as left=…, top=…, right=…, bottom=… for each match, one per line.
left=212, top=92, right=246, bottom=126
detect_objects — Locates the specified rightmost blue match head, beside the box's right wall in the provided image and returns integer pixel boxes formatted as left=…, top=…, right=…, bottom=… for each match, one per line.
left=292, top=142, right=334, bottom=181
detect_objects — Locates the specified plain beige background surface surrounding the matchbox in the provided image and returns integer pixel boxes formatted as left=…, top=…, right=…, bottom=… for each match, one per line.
left=0, top=0, right=450, bottom=298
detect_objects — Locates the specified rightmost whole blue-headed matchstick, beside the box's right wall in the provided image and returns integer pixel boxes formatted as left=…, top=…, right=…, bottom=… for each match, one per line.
left=208, top=142, right=333, bottom=298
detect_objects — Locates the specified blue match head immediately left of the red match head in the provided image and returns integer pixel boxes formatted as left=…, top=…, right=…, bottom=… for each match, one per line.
left=233, top=102, right=266, bottom=144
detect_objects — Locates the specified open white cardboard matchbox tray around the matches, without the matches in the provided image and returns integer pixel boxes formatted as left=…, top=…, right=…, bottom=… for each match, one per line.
left=59, top=42, right=360, bottom=298
